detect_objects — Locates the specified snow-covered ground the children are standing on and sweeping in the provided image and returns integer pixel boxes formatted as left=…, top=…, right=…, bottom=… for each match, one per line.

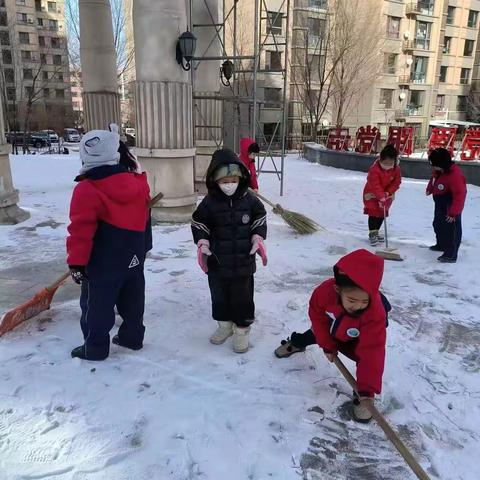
left=0, top=155, right=480, bottom=480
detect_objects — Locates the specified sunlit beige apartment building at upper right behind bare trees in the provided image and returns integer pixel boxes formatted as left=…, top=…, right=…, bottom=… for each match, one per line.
left=346, top=0, right=480, bottom=137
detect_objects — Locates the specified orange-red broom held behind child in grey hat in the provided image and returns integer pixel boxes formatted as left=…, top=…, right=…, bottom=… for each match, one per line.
left=0, top=193, right=163, bottom=337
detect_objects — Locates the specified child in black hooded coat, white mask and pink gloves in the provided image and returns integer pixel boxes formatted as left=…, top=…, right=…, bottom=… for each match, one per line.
left=192, top=149, right=267, bottom=353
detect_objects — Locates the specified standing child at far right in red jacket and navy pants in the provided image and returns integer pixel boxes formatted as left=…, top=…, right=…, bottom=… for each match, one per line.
left=426, top=148, right=467, bottom=263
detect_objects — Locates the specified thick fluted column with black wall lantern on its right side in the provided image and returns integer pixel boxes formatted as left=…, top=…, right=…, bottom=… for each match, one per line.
left=133, top=0, right=197, bottom=222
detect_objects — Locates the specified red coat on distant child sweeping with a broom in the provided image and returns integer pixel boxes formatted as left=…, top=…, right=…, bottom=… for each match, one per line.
left=363, top=160, right=402, bottom=218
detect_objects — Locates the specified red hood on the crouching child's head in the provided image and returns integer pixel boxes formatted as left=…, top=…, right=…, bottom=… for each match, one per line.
left=336, top=249, right=384, bottom=295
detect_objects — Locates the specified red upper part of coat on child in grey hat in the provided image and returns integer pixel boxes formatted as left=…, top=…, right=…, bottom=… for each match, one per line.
left=67, top=169, right=150, bottom=265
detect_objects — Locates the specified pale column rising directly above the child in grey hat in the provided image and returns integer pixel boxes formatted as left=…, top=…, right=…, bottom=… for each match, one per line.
left=78, top=0, right=121, bottom=130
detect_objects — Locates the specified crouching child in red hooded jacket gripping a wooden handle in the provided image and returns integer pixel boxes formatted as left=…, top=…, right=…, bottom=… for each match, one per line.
left=275, top=250, right=391, bottom=422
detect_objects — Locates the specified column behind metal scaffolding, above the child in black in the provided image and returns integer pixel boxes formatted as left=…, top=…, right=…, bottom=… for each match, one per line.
left=192, top=0, right=223, bottom=193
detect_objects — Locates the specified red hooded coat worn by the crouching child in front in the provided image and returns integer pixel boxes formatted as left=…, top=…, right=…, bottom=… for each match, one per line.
left=309, top=250, right=386, bottom=396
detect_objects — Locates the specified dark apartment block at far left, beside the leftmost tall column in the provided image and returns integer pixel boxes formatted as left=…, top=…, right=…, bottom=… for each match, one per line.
left=0, top=0, right=72, bottom=132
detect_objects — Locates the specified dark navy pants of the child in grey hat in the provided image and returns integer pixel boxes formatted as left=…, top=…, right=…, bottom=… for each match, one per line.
left=80, top=264, right=145, bottom=359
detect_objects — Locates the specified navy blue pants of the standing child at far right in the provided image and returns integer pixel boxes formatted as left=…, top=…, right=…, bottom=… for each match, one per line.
left=433, top=195, right=462, bottom=260
